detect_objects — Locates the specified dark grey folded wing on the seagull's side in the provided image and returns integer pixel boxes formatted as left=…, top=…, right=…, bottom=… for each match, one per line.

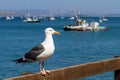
left=24, top=44, right=45, bottom=60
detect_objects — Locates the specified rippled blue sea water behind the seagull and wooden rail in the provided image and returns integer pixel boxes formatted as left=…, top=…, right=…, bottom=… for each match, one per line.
left=0, top=17, right=120, bottom=80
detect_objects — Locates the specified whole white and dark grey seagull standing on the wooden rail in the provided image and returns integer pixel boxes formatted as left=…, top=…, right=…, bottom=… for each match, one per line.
left=14, top=28, right=60, bottom=75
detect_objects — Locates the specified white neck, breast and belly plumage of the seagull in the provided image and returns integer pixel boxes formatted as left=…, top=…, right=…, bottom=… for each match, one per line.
left=37, top=29, right=55, bottom=61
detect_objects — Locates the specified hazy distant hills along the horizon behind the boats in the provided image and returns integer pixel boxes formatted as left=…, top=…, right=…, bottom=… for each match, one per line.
left=0, top=9, right=120, bottom=17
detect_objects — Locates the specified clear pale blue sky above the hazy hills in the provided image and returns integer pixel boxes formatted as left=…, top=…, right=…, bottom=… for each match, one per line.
left=0, top=0, right=120, bottom=14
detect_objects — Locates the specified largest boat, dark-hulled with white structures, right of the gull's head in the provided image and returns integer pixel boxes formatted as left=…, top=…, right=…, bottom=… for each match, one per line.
left=63, top=19, right=107, bottom=31
